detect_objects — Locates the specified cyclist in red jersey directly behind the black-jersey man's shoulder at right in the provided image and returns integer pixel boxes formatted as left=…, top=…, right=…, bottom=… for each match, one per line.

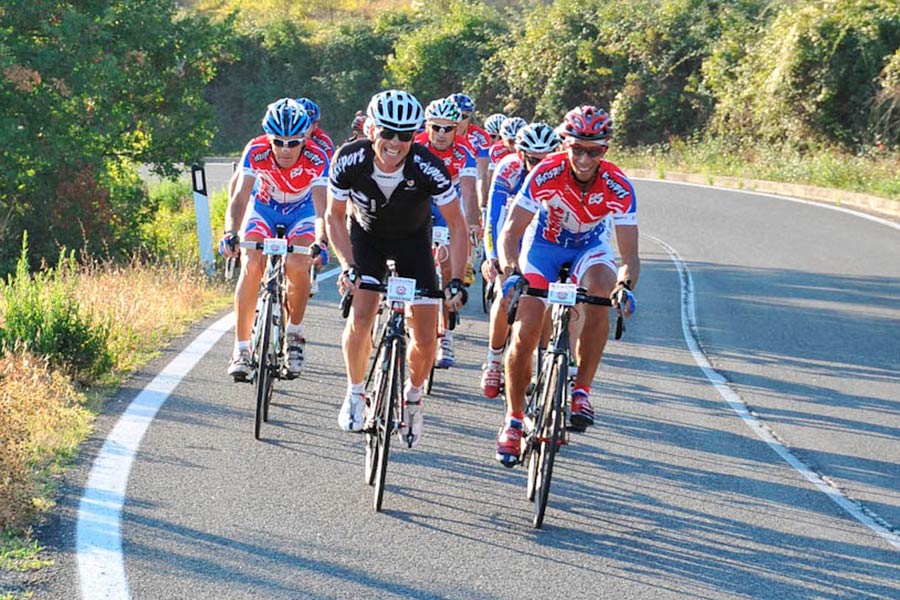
left=416, top=98, right=480, bottom=369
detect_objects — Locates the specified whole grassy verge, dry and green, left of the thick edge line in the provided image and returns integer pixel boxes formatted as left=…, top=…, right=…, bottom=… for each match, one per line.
left=0, top=190, right=232, bottom=580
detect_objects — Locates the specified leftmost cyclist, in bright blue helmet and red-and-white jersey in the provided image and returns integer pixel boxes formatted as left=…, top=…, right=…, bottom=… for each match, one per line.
left=219, top=98, right=329, bottom=381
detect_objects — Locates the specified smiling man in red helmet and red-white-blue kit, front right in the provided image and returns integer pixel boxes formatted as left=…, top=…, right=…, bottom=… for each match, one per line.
left=496, top=106, right=640, bottom=466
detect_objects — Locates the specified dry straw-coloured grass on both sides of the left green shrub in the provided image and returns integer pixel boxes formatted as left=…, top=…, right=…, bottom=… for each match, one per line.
left=0, top=263, right=230, bottom=531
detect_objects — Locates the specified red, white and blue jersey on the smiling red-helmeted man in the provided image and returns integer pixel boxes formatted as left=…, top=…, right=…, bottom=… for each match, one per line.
left=516, top=152, right=637, bottom=248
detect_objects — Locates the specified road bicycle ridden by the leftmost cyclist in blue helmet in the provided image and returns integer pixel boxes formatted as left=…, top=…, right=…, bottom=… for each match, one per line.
left=226, top=225, right=319, bottom=439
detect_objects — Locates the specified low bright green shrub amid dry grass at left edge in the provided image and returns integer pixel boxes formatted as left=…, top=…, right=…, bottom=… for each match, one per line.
left=0, top=235, right=113, bottom=385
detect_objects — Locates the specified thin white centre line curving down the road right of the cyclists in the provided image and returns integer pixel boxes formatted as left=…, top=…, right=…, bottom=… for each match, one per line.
left=647, top=232, right=900, bottom=549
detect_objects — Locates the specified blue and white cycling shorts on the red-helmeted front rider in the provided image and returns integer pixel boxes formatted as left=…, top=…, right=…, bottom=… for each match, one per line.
left=519, top=231, right=617, bottom=301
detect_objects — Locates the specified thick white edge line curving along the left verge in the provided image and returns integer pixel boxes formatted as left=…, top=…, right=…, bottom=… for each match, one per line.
left=75, top=268, right=341, bottom=600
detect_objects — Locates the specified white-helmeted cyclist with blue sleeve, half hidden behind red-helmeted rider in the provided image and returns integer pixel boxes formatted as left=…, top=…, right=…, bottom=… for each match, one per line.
left=481, top=119, right=561, bottom=398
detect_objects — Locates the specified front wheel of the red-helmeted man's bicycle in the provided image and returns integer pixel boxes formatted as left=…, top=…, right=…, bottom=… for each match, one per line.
left=532, top=354, right=569, bottom=529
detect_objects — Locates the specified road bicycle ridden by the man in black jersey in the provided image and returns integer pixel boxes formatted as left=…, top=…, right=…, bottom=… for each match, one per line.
left=341, top=276, right=444, bottom=511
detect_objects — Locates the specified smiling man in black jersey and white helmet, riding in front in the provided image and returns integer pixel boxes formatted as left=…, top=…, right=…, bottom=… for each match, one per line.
left=325, top=90, right=468, bottom=446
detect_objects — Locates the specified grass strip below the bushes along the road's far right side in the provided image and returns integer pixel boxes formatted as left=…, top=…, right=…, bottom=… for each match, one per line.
left=609, top=139, right=900, bottom=200
